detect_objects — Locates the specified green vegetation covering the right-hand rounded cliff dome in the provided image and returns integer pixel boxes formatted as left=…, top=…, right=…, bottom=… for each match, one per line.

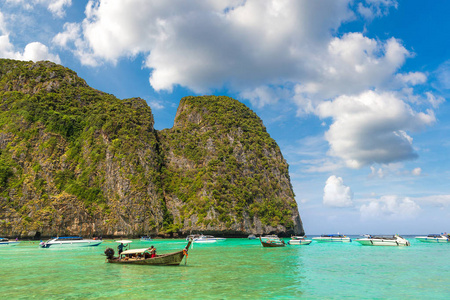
left=161, top=96, right=297, bottom=229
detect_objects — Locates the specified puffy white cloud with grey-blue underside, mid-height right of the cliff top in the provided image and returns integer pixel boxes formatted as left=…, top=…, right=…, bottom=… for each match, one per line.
left=317, top=91, right=435, bottom=168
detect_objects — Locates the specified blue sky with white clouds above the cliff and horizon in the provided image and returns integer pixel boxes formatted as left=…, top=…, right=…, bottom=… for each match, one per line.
left=0, top=0, right=450, bottom=235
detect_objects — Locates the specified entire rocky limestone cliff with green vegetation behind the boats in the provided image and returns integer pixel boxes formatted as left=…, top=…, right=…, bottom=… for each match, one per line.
left=0, top=60, right=303, bottom=237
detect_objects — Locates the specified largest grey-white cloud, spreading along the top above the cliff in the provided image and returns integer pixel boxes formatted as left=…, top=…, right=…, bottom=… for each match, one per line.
left=54, top=0, right=353, bottom=92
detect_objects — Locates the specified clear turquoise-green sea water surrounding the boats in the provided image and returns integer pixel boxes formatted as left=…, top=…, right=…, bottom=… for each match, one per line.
left=0, top=237, right=450, bottom=299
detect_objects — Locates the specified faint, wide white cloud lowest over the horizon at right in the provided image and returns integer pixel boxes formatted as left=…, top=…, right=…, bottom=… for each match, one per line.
left=360, top=196, right=421, bottom=219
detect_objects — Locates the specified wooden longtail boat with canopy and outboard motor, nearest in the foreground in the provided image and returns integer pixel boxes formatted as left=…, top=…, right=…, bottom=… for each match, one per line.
left=105, top=240, right=192, bottom=266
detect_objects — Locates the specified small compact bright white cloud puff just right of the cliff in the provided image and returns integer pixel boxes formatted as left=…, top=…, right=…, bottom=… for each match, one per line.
left=323, top=175, right=353, bottom=207
